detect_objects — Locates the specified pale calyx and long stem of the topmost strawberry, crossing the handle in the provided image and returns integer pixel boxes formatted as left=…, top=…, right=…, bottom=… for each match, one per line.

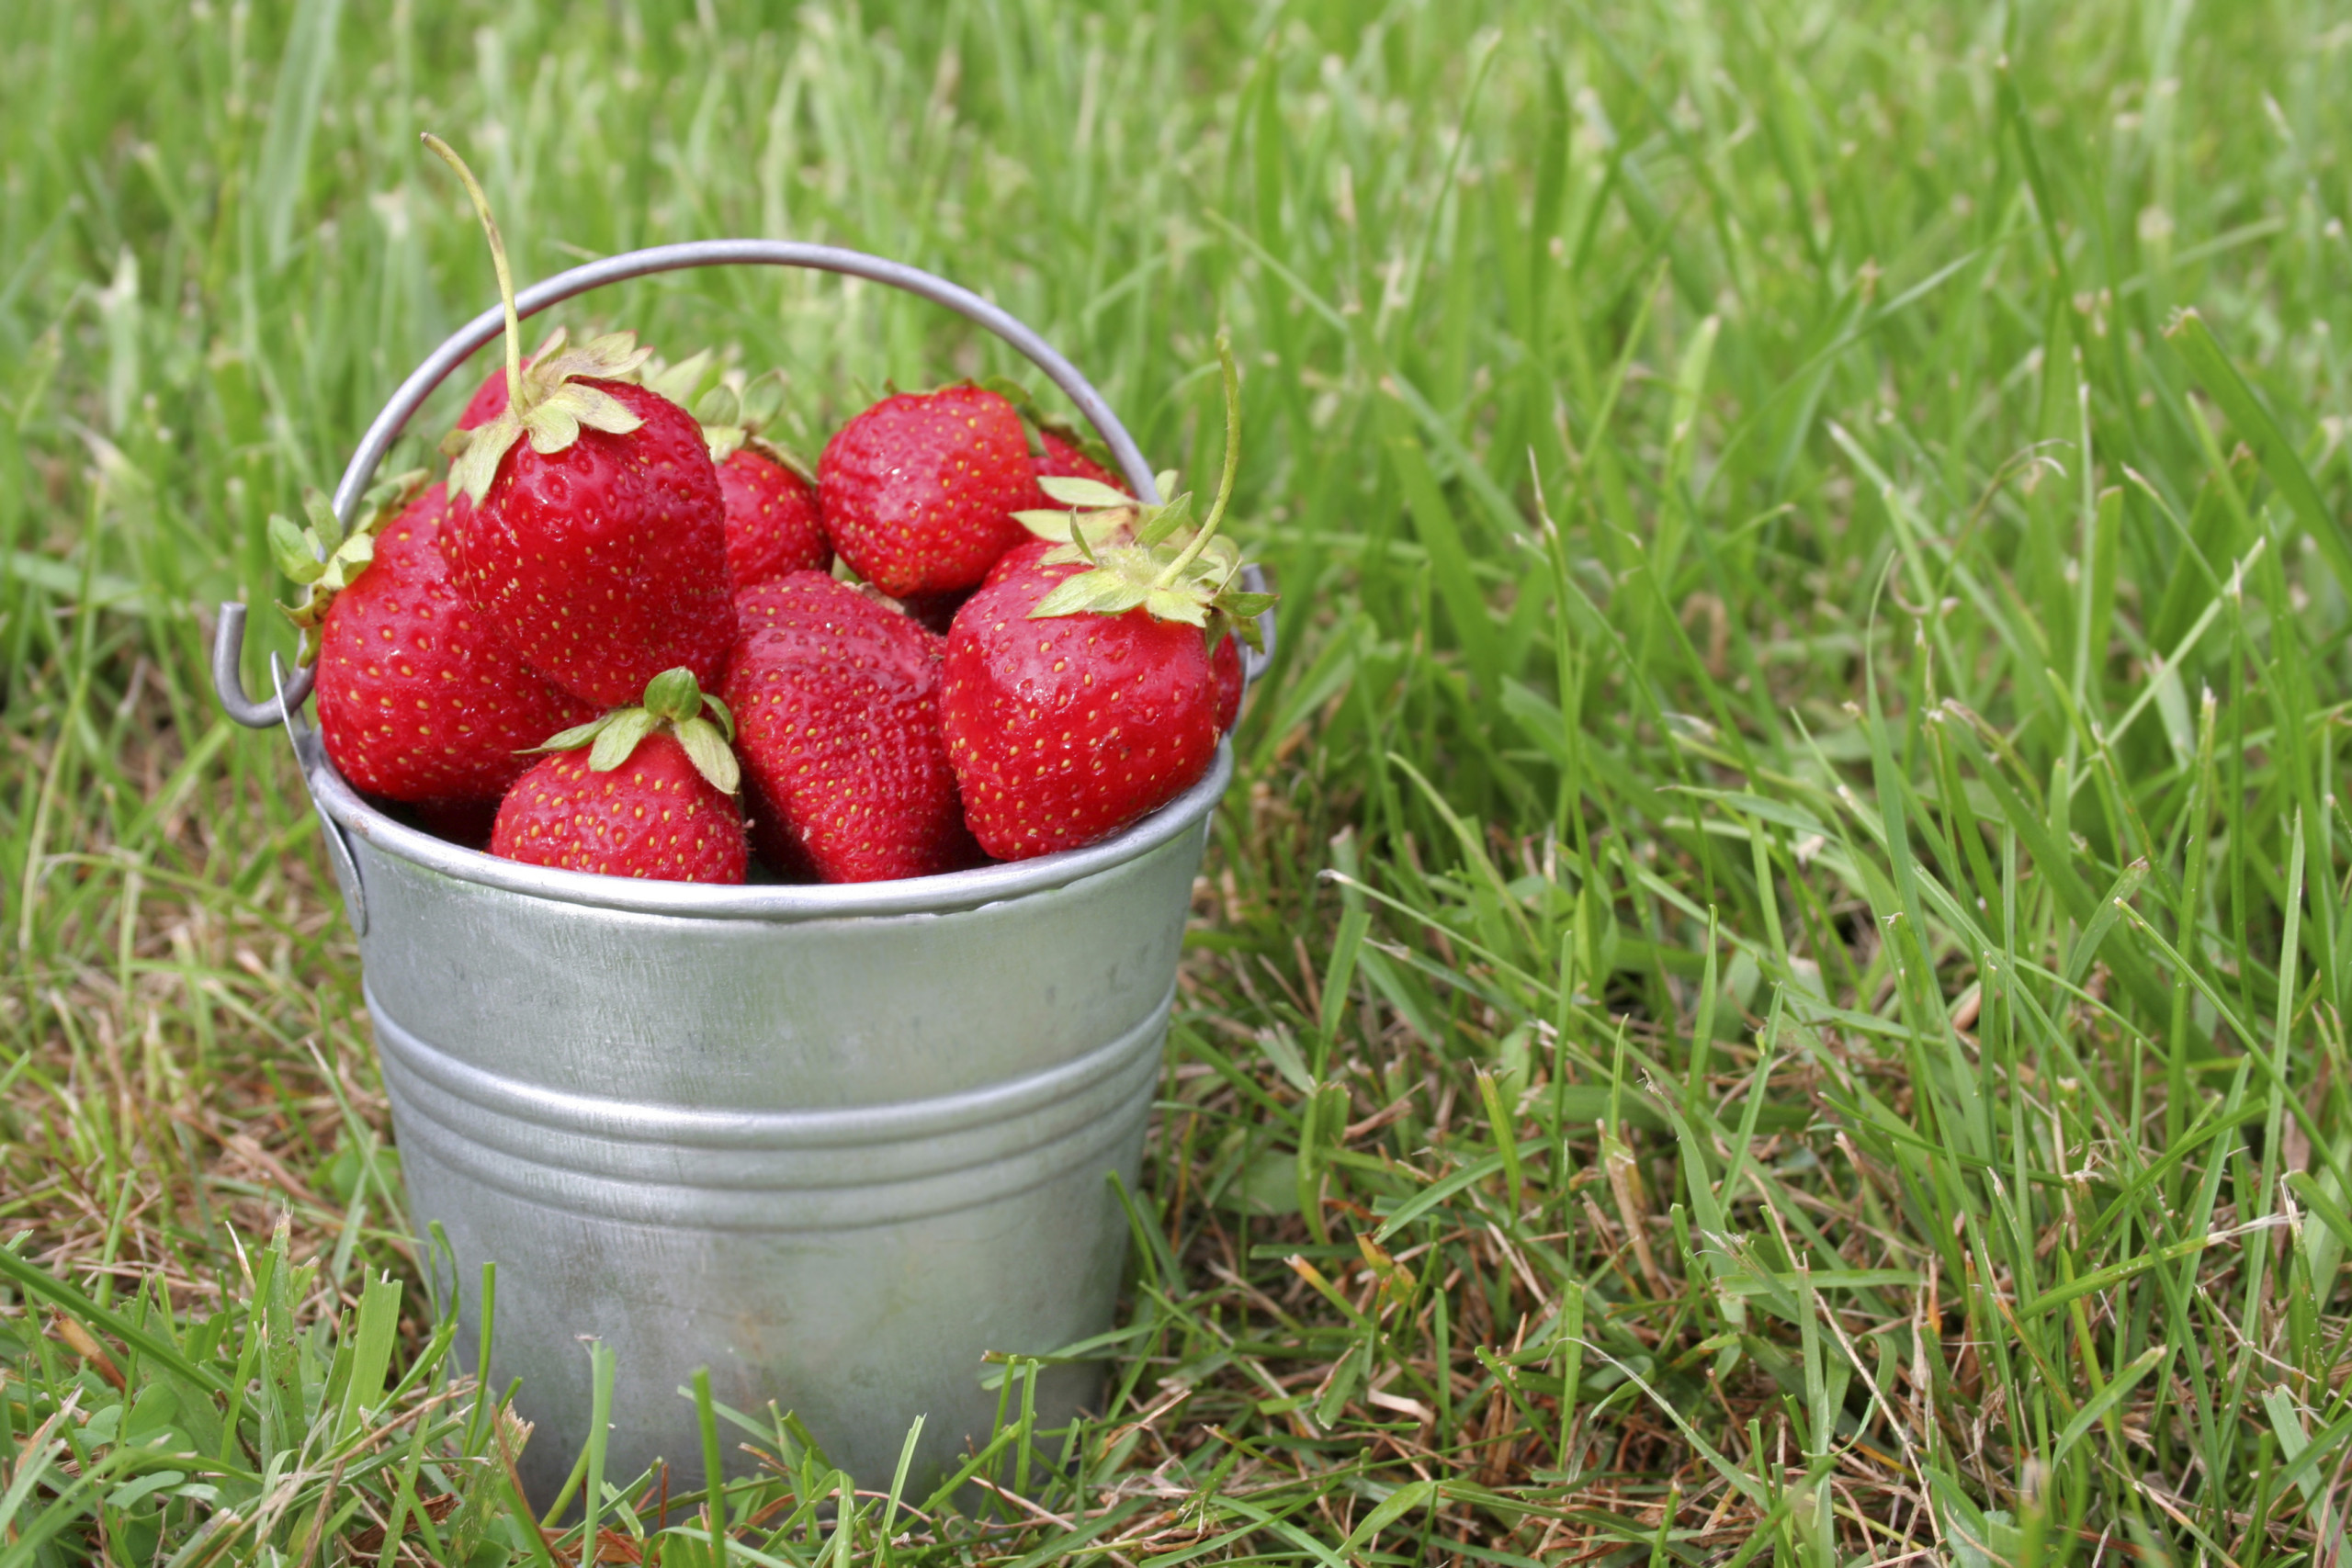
left=424, top=131, right=651, bottom=505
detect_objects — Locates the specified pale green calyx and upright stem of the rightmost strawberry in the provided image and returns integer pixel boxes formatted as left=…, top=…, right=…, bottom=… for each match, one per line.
left=1013, top=333, right=1275, bottom=649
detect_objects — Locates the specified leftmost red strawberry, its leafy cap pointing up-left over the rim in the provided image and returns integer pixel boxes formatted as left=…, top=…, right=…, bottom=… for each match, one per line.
left=270, top=472, right=595, bottom=823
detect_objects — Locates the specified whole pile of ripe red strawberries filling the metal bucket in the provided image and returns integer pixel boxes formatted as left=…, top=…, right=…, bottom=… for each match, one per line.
left=270, top=139, right=1268, bottom=882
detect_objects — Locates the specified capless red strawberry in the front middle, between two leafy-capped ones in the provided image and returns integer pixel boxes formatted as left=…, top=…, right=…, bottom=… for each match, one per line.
left=727, top=571, right=981, bottom=882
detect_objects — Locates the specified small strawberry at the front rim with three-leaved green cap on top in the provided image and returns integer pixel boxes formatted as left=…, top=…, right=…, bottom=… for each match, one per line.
left=489, top=668, right=751, bottom=882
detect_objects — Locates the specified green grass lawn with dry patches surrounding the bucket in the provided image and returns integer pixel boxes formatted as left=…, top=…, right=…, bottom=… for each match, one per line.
left=0, top=0, right=2352, bottom=1568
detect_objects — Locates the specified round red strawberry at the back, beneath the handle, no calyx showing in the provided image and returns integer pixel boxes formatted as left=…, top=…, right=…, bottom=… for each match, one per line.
left=816, top=386, right=1037, bottom=600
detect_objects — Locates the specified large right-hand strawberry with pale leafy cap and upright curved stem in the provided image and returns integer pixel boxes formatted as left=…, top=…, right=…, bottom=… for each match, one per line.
left=941, top=339, right=1270, bottom=861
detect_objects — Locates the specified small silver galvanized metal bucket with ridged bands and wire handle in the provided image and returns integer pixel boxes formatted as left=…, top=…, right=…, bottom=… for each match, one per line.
left=214, top=240, right=1263, bottom=1505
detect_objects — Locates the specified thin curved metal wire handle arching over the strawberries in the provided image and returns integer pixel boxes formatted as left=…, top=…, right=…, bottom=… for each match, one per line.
left=211, top=240, right=1275, bottom=728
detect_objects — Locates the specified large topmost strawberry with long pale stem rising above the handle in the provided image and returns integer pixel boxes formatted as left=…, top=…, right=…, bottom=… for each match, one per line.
left=425, top=136, right=734, bottom=705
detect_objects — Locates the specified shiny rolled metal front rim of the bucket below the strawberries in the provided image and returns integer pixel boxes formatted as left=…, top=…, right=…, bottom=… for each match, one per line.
left=317, top=731, right=1232, bottom=924
